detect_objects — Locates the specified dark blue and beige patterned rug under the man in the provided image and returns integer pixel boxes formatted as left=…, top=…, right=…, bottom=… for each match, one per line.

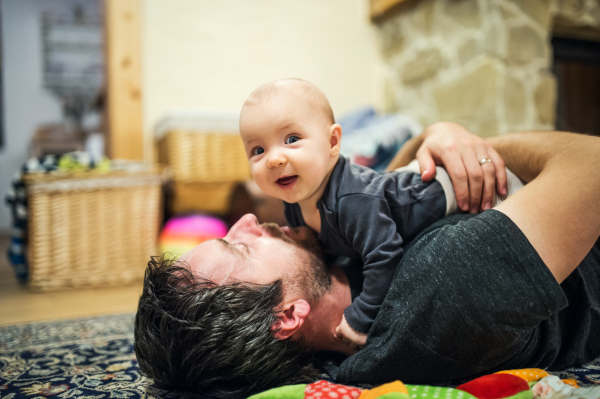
left=0, top=314, right=600, bottom=399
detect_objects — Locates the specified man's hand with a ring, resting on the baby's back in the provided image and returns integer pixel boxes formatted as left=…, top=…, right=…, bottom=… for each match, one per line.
left=416, top=122, right=507, bottom=213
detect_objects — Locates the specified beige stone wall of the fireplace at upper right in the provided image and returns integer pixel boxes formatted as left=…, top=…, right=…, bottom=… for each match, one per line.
left=378, top=0, right=600, bottom=136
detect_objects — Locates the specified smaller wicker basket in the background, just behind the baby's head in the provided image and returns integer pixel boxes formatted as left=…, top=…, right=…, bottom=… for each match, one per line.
left=158, top=130, right=250, bottom=183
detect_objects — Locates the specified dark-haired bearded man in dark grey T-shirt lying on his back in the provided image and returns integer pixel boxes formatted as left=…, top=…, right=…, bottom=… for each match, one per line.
left=135, top=126, right=600, bottom=397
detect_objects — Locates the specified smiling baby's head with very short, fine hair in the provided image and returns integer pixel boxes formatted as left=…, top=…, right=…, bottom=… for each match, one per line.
left=240, top=79, right=342, bottom=205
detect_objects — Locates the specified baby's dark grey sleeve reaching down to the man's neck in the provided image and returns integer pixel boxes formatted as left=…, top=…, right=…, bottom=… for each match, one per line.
left=337, top=194, right=404, bottom=333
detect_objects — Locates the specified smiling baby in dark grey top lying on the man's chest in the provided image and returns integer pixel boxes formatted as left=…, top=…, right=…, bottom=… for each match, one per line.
left=240, top=79, right=456, bottom=348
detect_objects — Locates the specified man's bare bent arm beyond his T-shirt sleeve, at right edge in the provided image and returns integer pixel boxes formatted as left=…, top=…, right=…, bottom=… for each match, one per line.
left=489, top=132, right=600, bottom=282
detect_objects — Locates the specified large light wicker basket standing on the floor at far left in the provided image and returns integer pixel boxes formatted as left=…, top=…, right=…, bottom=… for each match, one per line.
left=25, top=170, right=162, bottom=291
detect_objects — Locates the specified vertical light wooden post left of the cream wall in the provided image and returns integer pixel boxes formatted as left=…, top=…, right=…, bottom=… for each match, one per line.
left=105, top=0, right=144, bottom=160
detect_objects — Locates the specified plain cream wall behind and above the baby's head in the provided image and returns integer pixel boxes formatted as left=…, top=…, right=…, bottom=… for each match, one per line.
left=142, top=0, right=383, bottom=161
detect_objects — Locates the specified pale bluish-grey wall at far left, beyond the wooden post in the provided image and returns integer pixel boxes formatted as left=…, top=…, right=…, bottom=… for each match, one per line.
left=0, top=0, right=65, bottom=231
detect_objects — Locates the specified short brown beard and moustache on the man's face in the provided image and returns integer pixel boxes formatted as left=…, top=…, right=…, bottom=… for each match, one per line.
left=261, top=223, right=331, bottom=301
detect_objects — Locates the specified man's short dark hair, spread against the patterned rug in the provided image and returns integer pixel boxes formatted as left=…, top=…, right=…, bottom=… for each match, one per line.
left=134, top=257, right=311, bottom=398
